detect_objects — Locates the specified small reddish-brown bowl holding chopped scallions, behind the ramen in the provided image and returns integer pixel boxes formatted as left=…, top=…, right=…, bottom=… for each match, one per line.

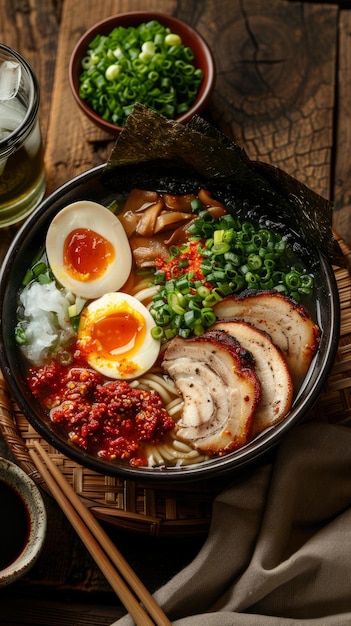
left=69, top=11, right=216, bottom=136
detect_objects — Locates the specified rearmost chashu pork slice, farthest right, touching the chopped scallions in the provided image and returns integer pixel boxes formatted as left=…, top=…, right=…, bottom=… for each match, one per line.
left=214, top=291, right=320, bottom=386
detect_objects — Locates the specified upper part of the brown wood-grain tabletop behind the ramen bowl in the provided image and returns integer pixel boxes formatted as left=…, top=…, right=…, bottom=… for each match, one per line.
left=0, top=0, right=351, bottom=240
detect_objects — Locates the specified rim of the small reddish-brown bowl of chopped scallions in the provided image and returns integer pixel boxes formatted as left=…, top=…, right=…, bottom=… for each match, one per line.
left=68, top=11, right=216, bottom=135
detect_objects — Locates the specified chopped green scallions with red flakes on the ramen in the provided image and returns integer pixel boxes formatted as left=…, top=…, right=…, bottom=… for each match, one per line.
left=150, top=202, right=314, bottom=339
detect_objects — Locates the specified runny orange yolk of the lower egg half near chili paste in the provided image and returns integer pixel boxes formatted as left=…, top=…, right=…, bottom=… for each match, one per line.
left=91, top=312, right=146, bottom=356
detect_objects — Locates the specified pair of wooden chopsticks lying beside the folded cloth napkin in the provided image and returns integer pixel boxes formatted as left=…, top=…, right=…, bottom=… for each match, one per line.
left=29, top=441, right=171, bottom=626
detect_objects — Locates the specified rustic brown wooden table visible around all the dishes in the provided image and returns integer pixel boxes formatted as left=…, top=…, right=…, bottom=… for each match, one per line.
left=0, top=0, right=351, bottom=626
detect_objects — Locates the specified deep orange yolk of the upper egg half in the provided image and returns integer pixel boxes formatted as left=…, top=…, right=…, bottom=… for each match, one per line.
left=63, top=228, right=115, bottom=281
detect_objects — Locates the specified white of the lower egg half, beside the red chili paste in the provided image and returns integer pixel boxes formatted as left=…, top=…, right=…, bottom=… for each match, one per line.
left=77, top=292, right=160, bottom=380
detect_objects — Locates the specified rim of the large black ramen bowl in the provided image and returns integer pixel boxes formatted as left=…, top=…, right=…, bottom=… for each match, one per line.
left=0, top=164, right=340, bottom=484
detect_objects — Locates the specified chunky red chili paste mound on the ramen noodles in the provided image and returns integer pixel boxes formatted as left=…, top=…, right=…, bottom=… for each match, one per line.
left=28, top=352, right=175, bottom=466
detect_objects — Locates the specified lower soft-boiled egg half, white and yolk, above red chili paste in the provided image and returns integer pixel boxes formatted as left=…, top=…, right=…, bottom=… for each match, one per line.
left=77, top=292, right=160, bottom=379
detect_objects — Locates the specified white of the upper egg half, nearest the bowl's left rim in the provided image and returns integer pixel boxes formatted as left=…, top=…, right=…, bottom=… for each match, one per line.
left=46, top=200, right=132, bottom=300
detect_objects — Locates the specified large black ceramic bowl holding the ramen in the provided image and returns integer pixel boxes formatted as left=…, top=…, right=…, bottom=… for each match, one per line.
left=0, top=166, right=339, bottom=484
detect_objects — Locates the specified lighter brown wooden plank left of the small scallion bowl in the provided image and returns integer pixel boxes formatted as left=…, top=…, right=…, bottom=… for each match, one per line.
left=46, top=0, right=179, bottom=192
